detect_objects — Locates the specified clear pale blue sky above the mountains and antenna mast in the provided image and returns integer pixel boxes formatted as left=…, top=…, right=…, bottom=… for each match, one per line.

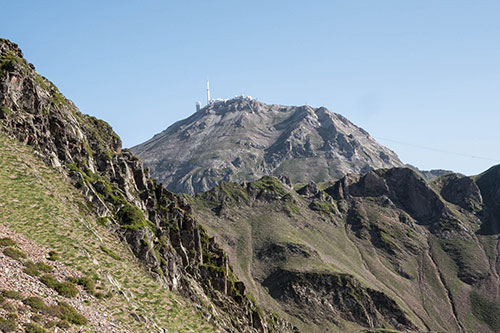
left=0, top=0, right=500, bottom=174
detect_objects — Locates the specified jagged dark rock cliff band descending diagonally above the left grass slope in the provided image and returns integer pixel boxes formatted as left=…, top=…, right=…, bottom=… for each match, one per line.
left=0, top=39, right=292, bottom=332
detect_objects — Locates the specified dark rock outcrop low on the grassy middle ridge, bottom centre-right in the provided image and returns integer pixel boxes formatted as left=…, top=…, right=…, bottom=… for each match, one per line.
left=263, top=269, right=416, bottom=330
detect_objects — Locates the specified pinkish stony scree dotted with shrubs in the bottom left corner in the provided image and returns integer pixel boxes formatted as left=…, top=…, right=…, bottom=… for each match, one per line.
left=0, top=225, right=118, bottom=332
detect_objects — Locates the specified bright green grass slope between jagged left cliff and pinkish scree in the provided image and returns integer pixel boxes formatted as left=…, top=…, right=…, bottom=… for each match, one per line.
left=0, top=135, right=215, bottom=332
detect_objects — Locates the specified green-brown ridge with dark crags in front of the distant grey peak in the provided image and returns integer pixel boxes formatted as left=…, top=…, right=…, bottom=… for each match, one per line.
left=192, top=167, right=500, bottom=332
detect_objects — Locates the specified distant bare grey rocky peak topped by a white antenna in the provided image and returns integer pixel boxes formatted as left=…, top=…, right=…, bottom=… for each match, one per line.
left=131, top=97, right=403, bottom=194
